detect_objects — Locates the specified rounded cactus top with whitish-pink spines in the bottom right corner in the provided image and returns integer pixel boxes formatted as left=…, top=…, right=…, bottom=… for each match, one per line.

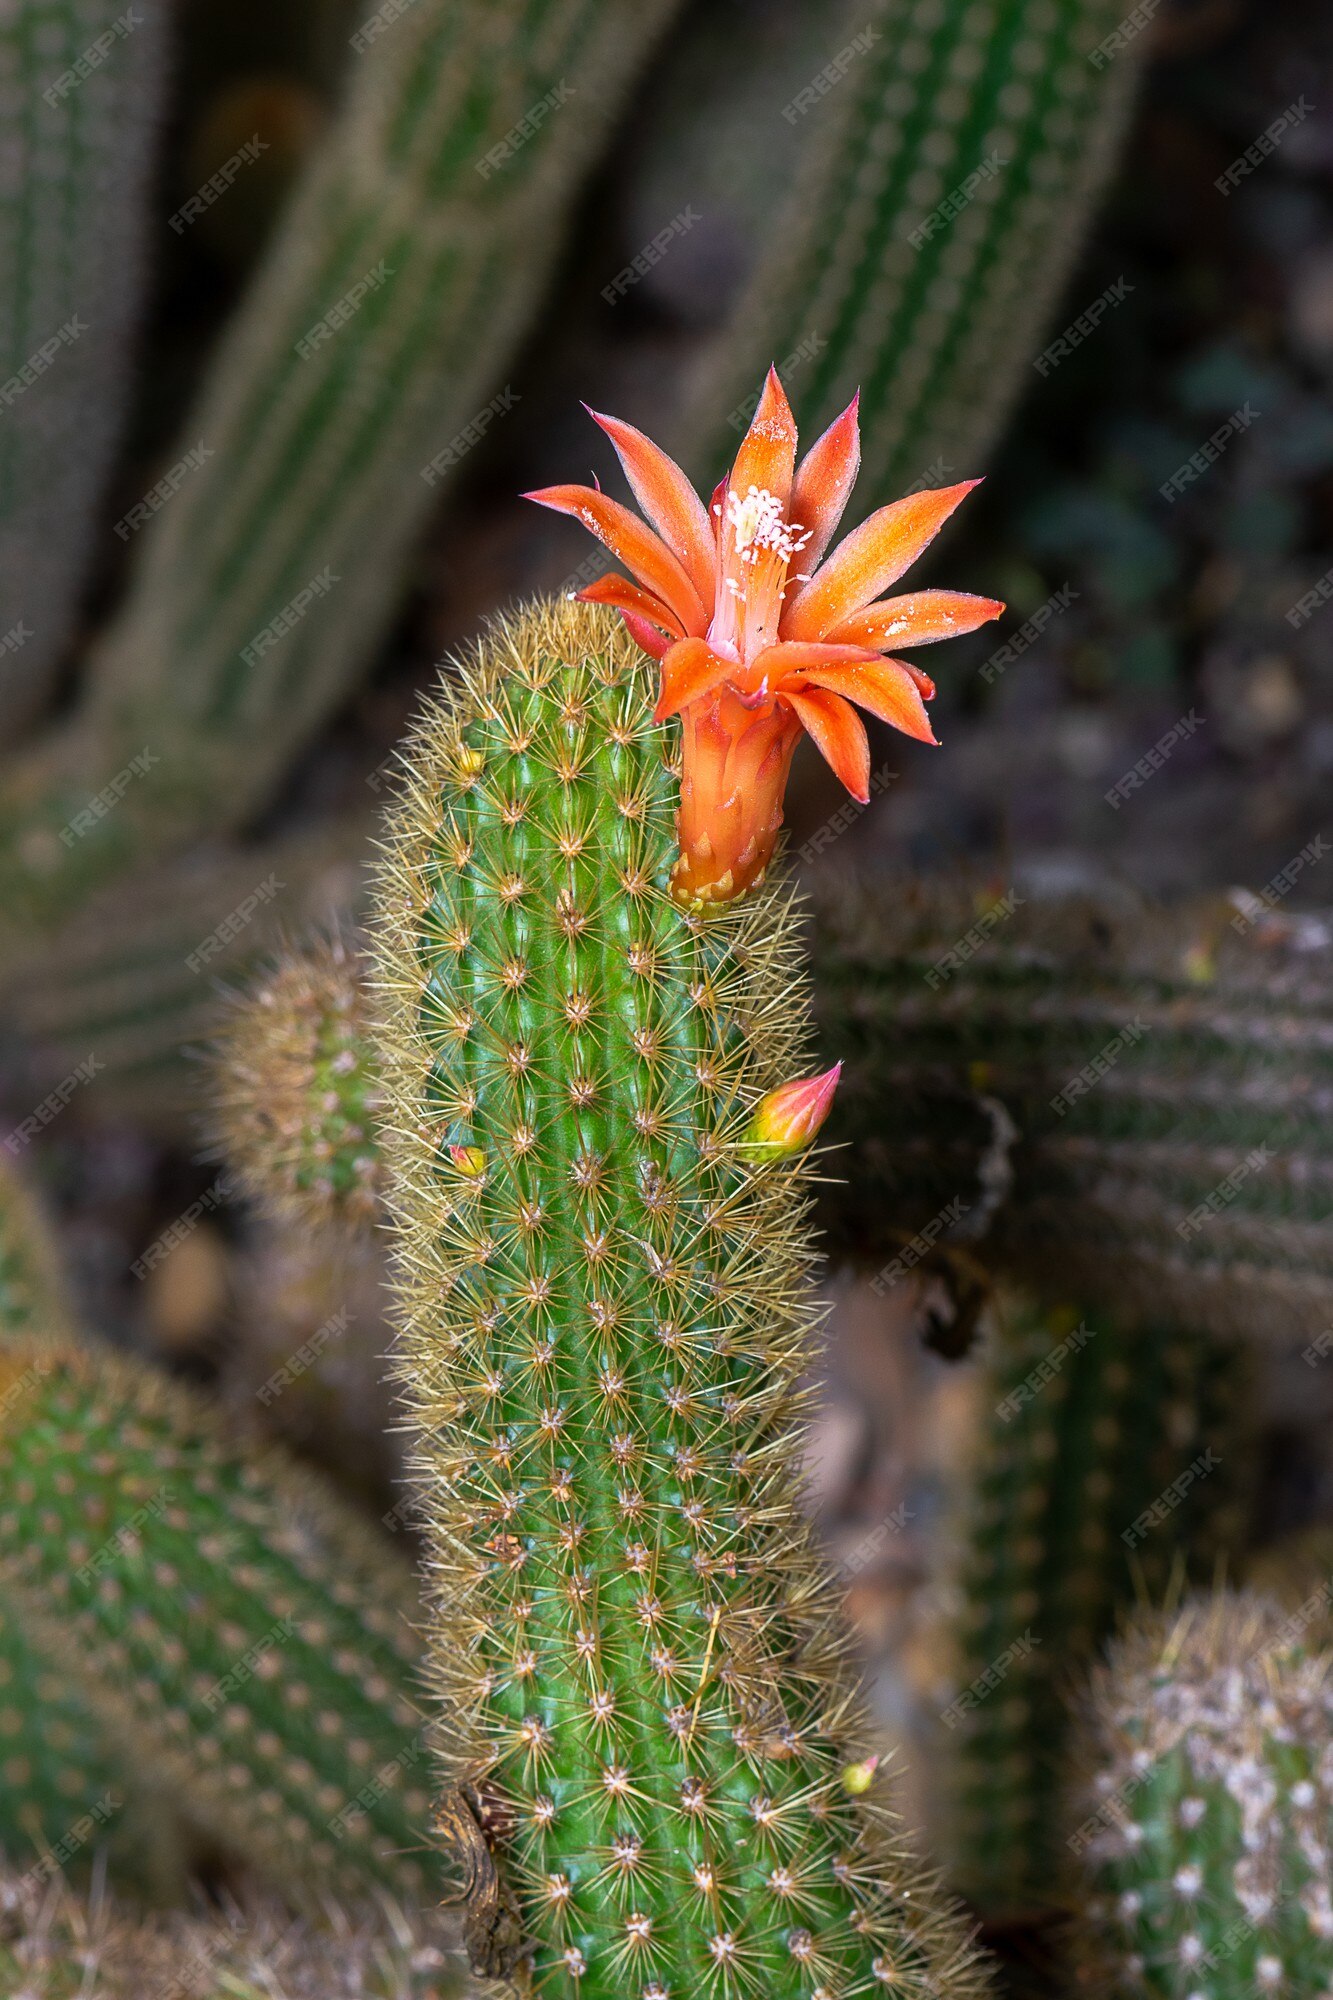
left=1069, top=1594, right=1333, bottom=2000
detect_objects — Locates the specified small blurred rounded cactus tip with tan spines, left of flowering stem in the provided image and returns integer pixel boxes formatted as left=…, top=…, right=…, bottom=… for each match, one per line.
left=216, top=936, right=378, bottom=1228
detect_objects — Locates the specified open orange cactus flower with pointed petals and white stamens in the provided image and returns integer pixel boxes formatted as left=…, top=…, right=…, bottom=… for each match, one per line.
left=524, top=368, right=1005, bottom=906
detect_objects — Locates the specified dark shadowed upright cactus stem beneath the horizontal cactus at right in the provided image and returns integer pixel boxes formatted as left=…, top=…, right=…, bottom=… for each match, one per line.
left=945, top=1308, right=1249, bottom=1916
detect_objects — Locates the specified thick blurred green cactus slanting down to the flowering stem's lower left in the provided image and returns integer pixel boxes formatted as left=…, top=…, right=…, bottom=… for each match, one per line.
left=0, top=1336, right=442, bottom=1896
